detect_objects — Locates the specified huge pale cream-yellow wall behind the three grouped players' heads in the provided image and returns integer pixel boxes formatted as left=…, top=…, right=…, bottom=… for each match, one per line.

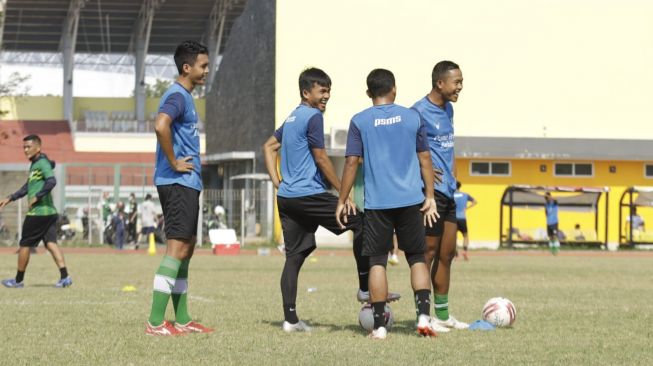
left=275, top=0, right=653, bottom=139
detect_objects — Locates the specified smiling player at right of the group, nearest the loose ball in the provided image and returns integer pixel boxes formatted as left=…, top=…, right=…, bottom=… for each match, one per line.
left=413, top=61, right=469, bottom=332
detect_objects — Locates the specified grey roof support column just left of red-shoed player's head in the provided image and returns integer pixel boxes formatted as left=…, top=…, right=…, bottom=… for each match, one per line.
left=133, top=0, right=161, bottom=124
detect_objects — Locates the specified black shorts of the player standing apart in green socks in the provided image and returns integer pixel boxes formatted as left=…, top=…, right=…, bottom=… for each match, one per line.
left=156, top=184, right=200, bottom=241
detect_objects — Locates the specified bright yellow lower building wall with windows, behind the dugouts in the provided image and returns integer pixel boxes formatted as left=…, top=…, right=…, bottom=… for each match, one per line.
left=456, top=159, right=653, bottom=242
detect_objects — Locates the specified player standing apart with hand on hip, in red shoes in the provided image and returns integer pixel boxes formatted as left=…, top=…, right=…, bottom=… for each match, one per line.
left=145, top=41, right=213, bottom=336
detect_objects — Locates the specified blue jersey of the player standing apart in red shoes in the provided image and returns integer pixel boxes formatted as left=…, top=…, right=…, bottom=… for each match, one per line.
left=154, top=82, right=202, bottom=191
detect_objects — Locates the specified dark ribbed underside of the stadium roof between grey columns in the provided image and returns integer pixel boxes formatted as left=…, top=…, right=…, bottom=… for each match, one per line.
left=2, top=0, right=246, bottom=54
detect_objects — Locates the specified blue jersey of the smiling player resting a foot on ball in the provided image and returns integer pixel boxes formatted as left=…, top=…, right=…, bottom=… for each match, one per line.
left=274, top=104, right=326, bottom=198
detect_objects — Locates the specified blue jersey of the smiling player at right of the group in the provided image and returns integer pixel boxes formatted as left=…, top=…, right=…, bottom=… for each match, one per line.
left=412, top=96, right=456, bottom=198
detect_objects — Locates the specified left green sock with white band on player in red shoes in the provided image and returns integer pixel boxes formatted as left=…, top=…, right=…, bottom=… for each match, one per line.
left=149, top=256, right=181, bottom=326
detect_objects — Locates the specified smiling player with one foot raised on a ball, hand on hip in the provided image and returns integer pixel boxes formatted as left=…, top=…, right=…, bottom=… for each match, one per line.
left=263, top=68, right=400, bottom=332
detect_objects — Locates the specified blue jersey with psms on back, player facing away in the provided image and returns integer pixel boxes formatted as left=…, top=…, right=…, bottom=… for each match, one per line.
left=345, top=104, right=428, bottom=210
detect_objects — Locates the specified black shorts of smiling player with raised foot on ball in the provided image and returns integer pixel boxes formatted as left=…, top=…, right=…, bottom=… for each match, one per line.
left=277, top=192, right=363, bottom=257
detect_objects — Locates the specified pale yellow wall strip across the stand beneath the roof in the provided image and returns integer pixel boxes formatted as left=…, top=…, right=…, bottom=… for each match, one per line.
left=0, top=96, right=206, bottom=121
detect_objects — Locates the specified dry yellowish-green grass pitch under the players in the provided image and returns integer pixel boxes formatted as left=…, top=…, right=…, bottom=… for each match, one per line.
left=0, top=252, right=653, bottom=365
